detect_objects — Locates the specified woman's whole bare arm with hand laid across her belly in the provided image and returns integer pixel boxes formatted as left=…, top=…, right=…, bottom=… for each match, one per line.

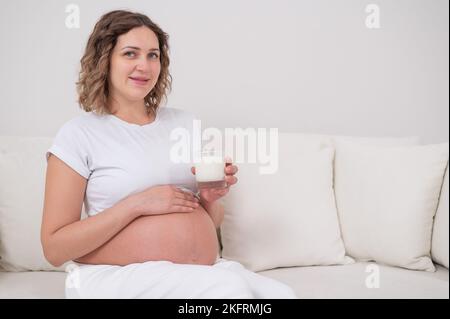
left=41, top=155, right=200, bottom=266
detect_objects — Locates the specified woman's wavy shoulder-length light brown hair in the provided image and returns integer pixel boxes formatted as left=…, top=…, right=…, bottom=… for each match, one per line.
left=77, top=10, right=172, bottom=114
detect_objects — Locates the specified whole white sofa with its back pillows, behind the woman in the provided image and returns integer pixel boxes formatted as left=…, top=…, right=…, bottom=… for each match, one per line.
left=0, top=134, right=449, bottom=298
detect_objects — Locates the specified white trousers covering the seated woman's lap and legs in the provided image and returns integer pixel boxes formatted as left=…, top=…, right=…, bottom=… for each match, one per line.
left=66, top=258, right=297, bottom=299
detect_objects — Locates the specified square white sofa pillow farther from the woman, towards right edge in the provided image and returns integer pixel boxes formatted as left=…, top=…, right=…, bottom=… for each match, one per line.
left=335, top=141, right=448, bottom=271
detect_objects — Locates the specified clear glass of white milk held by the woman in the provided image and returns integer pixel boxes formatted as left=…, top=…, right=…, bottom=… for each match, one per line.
left=195, top=150, right=227, bottom=189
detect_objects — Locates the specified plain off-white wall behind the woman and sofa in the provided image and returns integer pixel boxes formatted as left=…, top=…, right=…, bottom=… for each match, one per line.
left=0, top=0, right=449, bottom=143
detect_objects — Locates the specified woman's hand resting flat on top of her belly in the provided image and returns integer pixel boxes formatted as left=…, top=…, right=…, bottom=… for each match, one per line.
left=132, top=185, right=200, bottom=215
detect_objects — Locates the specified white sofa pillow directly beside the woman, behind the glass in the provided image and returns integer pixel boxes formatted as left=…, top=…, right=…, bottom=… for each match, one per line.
left=221, top=133, right=352, bottom=271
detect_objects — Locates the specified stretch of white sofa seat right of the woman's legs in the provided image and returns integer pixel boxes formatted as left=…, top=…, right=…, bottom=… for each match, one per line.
left=259, top=262, right=449, bottom=299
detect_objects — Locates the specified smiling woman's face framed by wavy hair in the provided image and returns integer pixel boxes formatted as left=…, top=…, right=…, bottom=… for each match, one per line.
left=108, top=26, right=161, bottom=102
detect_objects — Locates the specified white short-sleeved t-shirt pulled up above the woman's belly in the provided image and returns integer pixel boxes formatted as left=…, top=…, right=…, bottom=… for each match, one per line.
left=46, top=107, right=197, bottom=216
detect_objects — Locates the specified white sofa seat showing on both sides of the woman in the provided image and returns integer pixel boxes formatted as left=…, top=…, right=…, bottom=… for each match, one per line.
left=0, top=263, right=449, bottom=299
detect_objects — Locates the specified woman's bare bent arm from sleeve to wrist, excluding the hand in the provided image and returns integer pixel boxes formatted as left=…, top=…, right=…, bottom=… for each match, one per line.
left=41, top=155, right=139, bottom=266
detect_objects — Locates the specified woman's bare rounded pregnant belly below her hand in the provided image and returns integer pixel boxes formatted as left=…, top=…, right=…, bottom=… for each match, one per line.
left=77, top=206, right=219, bottom=265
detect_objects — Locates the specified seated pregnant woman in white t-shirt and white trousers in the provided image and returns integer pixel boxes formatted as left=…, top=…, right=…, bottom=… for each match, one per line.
left=41, top=10, right=295, bottom=298
